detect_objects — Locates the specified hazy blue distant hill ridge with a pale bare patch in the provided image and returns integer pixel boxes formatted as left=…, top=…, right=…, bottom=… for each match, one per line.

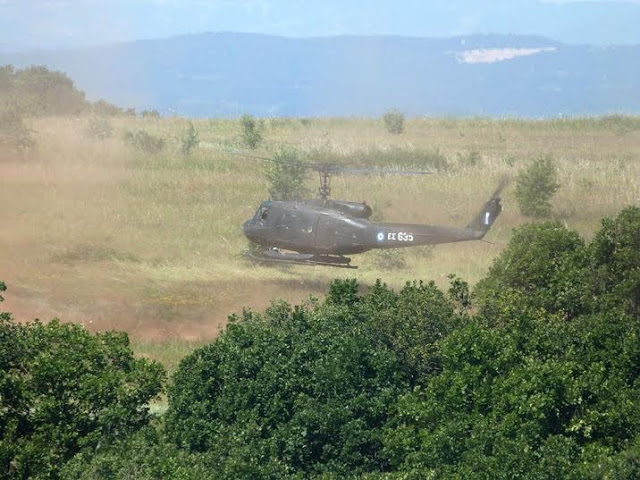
left=0, top=33, right=640, bottom=117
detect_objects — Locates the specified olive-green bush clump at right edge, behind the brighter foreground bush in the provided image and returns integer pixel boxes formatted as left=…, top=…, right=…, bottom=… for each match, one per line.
left=474, top=207, right=640, bottom=322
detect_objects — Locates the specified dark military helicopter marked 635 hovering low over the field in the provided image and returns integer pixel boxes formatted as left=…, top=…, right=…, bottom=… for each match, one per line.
left=242, top=155, right=507, bottom=268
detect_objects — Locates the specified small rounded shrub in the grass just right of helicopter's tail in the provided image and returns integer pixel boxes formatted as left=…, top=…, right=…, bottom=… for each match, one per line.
left=515, top=157, right=560, bottom=217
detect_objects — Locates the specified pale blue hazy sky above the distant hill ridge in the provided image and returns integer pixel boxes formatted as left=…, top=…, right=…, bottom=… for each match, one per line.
left=0, top=0, right=640, bottom=50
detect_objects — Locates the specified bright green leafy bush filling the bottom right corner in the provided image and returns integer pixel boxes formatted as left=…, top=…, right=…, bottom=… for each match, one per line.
left=384, top=312, right=640, bottom=479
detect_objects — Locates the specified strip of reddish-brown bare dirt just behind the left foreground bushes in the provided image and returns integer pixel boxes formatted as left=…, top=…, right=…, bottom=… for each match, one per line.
left=0, top=262, right=324, bottom=342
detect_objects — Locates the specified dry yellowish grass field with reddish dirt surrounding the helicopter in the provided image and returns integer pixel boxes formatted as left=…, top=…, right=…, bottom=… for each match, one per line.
left=0, top=116, right=640, bottom=368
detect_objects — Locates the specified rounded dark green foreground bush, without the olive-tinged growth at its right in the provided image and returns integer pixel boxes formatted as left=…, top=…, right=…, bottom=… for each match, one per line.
left=166, top=303, right=405, bottom=475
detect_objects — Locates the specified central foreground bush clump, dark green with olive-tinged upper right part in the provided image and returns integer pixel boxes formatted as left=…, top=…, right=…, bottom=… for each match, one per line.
left=166, top=280, right=454, bottom=476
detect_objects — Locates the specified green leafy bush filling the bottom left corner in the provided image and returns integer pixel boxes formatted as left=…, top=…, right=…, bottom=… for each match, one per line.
left=0, top=302, right=165, bottom=478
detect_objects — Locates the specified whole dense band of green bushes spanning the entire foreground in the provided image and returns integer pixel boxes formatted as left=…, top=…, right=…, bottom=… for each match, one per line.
left=0, top=207, right=640, bottom=479
